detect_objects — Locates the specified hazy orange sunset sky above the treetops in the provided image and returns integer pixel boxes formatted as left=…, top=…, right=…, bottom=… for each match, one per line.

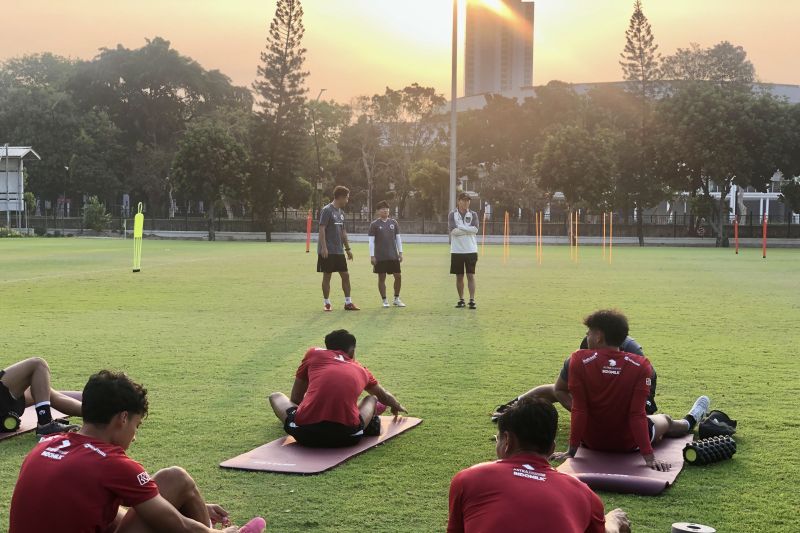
left=0, top=0, right=800, bottom=101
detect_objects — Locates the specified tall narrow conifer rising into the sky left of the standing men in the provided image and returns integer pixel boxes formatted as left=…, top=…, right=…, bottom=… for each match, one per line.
left=249, top=0, right=308, bottom=240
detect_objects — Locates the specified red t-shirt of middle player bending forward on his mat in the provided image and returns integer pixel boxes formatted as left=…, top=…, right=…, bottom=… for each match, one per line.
left=294, top=348, right=378, bottom=427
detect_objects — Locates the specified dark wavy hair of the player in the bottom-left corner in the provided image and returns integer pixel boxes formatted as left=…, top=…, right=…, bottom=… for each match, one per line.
left=81, top=370, right=148, bottom=425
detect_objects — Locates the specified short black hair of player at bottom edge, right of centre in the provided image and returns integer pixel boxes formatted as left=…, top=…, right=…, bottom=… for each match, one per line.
left=497, top=398, right=558, bottom=454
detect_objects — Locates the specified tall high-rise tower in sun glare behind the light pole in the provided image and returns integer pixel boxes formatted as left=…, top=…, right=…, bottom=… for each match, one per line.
left=464, top=0, right=534, bottom=96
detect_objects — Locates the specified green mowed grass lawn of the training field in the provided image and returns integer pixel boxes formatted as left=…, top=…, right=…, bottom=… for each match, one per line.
left=0, top=238, right=800, bottom=533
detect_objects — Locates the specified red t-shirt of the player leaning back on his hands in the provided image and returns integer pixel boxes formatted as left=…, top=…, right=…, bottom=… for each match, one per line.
left=568, top=349, right=653, bottom=455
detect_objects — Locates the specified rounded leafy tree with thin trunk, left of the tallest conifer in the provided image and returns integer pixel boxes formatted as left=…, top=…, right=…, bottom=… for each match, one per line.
left=171, top=120, right=247, bottom=241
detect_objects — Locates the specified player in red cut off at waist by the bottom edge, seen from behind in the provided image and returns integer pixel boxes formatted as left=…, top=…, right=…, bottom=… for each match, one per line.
left=447, top=398, right=630, bottom=533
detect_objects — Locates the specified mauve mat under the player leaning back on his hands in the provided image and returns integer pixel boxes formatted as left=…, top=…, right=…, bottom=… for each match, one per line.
left=556, top=435, right=692, bottom=496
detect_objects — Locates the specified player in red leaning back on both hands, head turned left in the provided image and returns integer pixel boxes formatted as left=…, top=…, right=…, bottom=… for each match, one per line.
left=553, top=310, right=710, bottom=471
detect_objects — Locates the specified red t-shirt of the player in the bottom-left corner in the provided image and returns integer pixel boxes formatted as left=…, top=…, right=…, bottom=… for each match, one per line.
left=9, top=433, right=158, bottom=533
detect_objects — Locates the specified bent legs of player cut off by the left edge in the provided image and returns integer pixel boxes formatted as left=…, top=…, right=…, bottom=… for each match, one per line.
left=0, top=357, right=81, bottom=436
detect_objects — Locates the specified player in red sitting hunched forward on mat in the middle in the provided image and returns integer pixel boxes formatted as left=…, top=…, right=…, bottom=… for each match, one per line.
left=269, top=329, right=407, bottom=448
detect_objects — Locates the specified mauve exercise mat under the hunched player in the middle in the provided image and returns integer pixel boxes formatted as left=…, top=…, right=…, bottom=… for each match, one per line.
left=219, top=416, right=422, bottom=474
